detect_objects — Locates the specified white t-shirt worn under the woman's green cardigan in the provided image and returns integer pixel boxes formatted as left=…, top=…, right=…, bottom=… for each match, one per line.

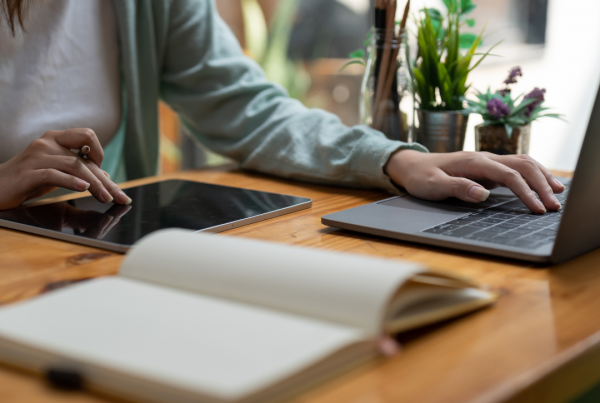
left=0, top=0, right=121, bottom=163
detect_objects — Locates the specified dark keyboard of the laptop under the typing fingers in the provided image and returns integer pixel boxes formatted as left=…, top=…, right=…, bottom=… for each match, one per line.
left=422, top=185, right=569, bottom=249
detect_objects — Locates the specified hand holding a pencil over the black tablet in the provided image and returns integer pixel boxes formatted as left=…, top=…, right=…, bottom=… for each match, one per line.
left=0, top=129, right=131, bottom=210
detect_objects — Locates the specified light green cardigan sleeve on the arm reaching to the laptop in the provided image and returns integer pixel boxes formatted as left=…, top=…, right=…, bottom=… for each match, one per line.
left=161, top=2, right=425, bottom=191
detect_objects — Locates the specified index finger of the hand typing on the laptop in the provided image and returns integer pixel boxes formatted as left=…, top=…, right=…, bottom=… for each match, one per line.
left=465, top=158, right=546, bottom=214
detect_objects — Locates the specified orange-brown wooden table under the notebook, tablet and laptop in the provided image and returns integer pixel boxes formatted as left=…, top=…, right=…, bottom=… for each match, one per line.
left=0, top=165, right=600, bottom=403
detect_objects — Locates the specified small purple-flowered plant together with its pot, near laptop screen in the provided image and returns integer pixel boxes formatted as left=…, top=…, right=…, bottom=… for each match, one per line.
left=467, top=67, right=562, bottom=155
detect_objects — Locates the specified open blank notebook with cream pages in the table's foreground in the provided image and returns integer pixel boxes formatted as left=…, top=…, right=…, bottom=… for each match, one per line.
left=0, top=230, right=494, bottom=403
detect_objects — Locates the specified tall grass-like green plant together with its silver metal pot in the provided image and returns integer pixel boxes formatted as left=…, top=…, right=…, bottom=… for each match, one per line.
left=410, top=0, right=493, bottom=152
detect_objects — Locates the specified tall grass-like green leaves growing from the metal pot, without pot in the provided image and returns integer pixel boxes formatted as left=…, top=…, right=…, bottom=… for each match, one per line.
left=410, top=0, right=496, bottom=111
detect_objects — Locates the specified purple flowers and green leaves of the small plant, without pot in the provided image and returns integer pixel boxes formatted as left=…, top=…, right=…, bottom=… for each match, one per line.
left=467, top=67, right=564, bottom=138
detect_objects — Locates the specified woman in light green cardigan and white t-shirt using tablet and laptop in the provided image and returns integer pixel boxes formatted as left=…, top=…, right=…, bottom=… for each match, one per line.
left=0, top=0, right=564, bottom=213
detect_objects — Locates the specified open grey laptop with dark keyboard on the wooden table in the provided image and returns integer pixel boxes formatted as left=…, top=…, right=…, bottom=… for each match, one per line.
left=321, top=87, right=600, bottom=263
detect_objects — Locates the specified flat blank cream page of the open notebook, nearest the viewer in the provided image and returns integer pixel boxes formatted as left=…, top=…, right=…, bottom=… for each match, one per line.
left=0, top=277, right=364, bottom=400
